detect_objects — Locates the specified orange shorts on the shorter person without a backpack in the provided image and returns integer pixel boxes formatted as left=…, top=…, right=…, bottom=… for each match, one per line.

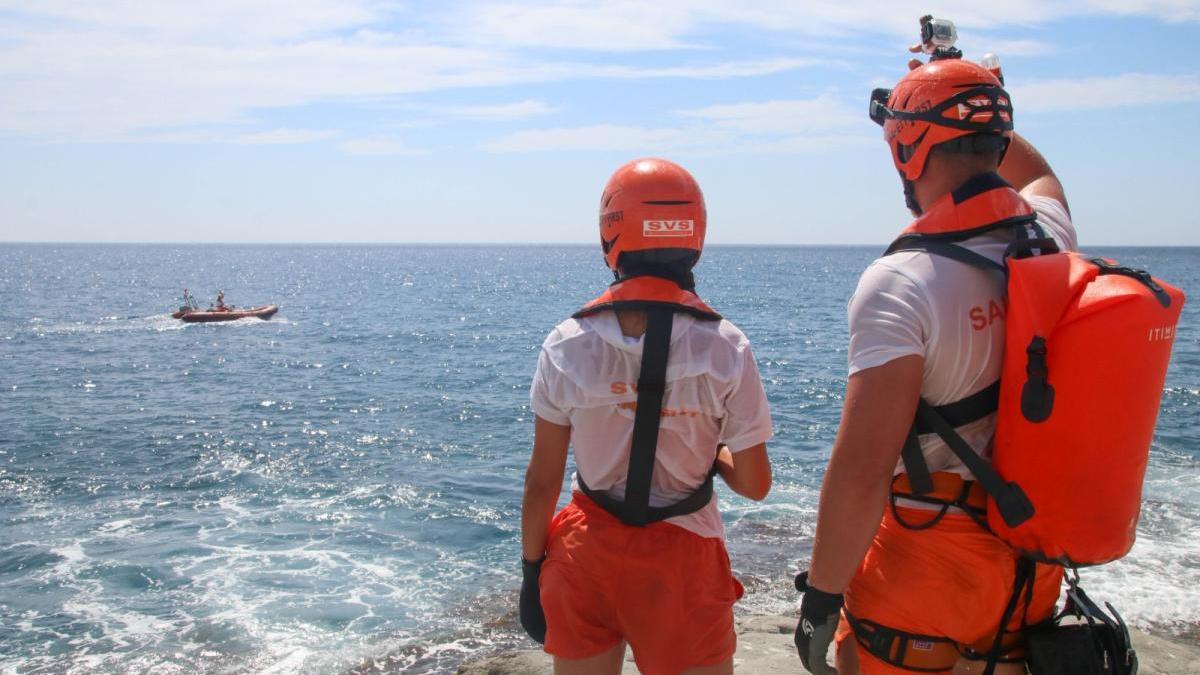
left=540, top=492, right=743, bottom=674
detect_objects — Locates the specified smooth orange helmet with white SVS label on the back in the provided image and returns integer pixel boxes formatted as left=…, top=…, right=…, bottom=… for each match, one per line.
left=600, top=157, right=707, bottom=271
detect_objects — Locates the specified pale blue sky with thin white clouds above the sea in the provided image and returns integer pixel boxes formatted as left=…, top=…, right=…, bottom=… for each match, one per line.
left=0, top=0, right=1200, bottom=246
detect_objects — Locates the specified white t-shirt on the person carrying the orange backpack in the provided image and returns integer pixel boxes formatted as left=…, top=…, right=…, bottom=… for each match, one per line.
left=848, top=197, right=1078, bottom=477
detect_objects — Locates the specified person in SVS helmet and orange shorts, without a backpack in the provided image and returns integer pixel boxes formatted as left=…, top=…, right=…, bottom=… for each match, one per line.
left=521, top=159, right=772, bottom=674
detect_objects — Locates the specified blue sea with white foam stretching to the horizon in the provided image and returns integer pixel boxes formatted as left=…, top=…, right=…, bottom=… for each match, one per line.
left=0, top=245, right=1200, bottom=673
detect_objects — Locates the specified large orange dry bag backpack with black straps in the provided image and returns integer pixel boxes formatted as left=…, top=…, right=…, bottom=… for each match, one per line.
left=988, top=252, right=1183, bottom=566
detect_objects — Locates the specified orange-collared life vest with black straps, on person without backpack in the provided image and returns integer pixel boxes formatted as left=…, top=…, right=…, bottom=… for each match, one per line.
left=572, top=276, right=721, bottom=527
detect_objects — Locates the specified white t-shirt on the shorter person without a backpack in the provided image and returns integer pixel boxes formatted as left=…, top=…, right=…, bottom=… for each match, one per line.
left=529, top=311, right=772, bottom=537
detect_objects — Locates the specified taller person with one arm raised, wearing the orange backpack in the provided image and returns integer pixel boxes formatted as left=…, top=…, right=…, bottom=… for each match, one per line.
left=796, top=58, right=1076, bottom=675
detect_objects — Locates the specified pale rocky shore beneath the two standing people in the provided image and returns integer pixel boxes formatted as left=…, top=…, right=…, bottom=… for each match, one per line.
left=458, top=616, right=1200, bottom=675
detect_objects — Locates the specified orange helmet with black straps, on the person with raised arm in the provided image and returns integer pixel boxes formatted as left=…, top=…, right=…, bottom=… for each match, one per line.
left=870, top=59, right=1013, bottom=180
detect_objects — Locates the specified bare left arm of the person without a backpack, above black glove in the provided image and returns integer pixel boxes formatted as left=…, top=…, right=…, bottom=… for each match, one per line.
left=521, top=417, right=571, bottom=562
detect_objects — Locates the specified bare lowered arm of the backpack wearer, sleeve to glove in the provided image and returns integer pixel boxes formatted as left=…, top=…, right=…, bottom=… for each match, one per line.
left=808, top=354, right=924, bottom=593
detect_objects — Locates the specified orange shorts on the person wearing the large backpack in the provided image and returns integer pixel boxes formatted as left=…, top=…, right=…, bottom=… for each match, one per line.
left=836, top=507, right=1062, bottom=675
